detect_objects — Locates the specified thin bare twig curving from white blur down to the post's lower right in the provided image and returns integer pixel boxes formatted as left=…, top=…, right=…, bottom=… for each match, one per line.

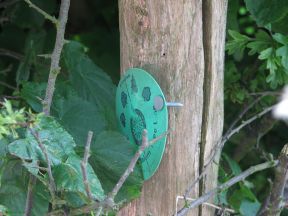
left=184, top=105, right=275, bottom=197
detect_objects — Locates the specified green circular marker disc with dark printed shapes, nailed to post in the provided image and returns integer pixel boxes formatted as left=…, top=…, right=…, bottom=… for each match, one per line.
left=116, top=68, right=168, bottom=180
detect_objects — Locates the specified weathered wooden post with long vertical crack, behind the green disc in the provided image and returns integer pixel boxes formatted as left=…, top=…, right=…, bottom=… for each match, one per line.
left=118, top=0, right=226, bottom=216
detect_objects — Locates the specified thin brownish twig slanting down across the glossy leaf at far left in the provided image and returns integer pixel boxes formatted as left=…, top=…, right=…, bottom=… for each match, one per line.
left=29, top=128, right=56, bottom=209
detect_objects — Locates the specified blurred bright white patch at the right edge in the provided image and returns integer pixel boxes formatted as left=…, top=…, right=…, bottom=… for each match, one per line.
left=273, top=86, right=288, bottom=120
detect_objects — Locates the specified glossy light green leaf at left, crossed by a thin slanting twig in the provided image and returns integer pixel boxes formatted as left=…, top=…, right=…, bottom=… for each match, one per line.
left=8, top=114, right=76, bottom=165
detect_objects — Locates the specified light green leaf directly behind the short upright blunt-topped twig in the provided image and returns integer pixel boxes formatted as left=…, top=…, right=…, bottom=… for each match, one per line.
left=53, top=155, right=105, bottom=201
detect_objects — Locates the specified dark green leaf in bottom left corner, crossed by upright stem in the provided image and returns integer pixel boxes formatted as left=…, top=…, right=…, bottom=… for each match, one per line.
left=0, top=160, right=50, bottom=216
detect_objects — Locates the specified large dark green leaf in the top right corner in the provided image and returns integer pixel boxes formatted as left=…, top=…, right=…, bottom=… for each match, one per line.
left=245, top=0, right=288, bottom=26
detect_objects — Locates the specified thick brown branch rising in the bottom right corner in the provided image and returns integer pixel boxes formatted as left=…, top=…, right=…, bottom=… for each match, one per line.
left=258, top=144, right=288, bottom=216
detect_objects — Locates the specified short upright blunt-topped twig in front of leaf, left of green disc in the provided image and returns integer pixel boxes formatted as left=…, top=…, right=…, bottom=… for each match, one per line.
left=81, top=131, right=93, bottom=201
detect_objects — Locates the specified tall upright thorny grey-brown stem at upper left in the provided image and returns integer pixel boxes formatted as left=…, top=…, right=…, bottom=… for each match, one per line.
left=43, top=0, right=70, bottom=115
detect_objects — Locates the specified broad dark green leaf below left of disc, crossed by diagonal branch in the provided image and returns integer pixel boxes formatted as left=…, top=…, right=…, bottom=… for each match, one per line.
left=90, top=131, right=143, bottom=201
